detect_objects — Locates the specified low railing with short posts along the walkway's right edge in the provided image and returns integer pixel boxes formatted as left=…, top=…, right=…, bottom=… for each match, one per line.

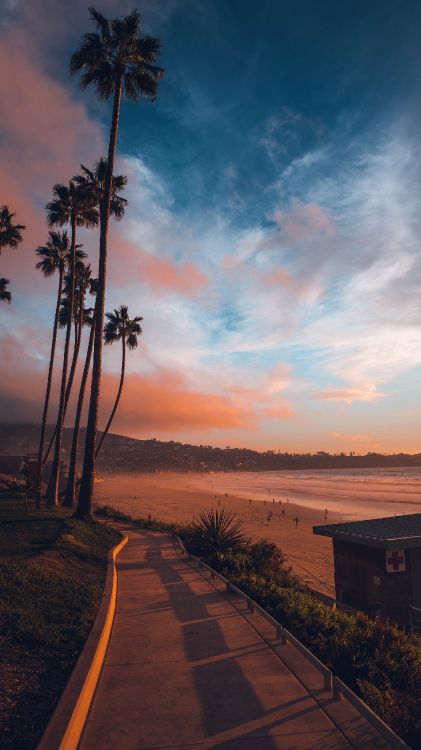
left=175, top=536, right=410, bottom=750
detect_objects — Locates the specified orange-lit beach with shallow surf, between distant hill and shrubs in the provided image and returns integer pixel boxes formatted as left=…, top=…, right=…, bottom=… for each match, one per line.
left=95, top=469, right=421, bottom=595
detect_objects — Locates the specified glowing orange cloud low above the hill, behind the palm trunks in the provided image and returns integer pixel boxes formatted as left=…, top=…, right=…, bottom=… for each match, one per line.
left=0, top=332, right=256, bottom=437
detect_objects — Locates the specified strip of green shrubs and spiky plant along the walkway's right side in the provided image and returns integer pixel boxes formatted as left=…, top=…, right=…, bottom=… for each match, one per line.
left=97, top=506, right=421, bottom=750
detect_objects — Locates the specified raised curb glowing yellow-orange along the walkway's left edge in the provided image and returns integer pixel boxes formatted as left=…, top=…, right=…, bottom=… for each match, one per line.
left=37, top=529, right=128, bottom=750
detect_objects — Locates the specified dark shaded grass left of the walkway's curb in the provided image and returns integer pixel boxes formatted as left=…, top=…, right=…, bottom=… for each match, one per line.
left=0, top=505, right=119, bottom=750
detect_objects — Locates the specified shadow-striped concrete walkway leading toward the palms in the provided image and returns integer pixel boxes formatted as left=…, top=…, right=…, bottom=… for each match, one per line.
left=80, top=530, right=389, bottom=750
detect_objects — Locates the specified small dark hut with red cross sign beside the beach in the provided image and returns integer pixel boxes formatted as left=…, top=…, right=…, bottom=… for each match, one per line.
left=313, top=513, right=421, bottom=627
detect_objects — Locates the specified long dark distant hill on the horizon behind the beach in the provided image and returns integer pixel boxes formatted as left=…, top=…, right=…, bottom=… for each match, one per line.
left=0, top=423, right=421, bottom=473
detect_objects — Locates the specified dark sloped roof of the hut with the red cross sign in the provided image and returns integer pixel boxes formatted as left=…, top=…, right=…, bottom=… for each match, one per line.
left=313, top=513, right=421, bottom=549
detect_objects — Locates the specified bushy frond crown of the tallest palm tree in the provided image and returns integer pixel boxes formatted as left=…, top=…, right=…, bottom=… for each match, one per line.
left=70, top=8, right=164, bottom=101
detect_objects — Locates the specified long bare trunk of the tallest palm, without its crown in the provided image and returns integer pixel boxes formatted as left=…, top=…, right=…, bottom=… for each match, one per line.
left=75, top=73, right=122, bottom=520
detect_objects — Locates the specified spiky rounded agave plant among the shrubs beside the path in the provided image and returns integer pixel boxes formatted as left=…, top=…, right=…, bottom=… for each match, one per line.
left=189, top=508, right=247, bottom=557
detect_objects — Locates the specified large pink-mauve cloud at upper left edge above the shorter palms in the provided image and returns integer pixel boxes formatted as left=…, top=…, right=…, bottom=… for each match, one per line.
left=0, top=29, right=102, bottom=288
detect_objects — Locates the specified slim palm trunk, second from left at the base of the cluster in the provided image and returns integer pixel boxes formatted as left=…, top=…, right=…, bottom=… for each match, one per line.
left=47, top=210, right=76, bottom=506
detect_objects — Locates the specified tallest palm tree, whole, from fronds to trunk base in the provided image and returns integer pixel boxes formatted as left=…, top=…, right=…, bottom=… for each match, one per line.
left=70, top=8, right=164, bottom=519
